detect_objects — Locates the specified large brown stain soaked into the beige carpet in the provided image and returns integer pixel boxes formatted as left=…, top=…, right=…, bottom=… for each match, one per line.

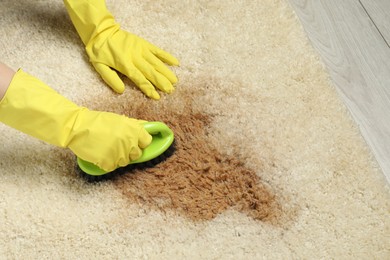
left=85, top=86, right=283, bottom=224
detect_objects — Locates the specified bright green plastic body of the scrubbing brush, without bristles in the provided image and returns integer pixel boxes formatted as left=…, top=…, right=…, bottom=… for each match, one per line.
left=77, top=122, right=174, bottom=176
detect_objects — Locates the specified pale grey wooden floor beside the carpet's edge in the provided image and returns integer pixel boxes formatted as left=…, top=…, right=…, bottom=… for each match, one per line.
left=290, top=0, right=390, bottom=182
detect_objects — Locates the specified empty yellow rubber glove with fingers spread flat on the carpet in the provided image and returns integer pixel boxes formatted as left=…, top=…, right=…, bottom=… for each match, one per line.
left=64, top=0, right=179, bottom=99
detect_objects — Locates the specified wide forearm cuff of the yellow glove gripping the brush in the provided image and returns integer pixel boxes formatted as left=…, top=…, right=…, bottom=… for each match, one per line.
left=0, top=70, right=81, bottom=147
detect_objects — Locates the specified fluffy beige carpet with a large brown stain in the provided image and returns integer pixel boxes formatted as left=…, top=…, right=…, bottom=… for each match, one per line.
left=0, top=0, right=390, bottom=259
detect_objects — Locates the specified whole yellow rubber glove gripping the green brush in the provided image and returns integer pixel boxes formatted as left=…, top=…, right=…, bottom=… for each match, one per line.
left=0, top=70, right=152, bottom=172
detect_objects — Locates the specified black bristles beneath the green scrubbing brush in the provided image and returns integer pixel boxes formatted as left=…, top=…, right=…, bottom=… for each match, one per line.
left=77, top=141, right=176, bottom=182
